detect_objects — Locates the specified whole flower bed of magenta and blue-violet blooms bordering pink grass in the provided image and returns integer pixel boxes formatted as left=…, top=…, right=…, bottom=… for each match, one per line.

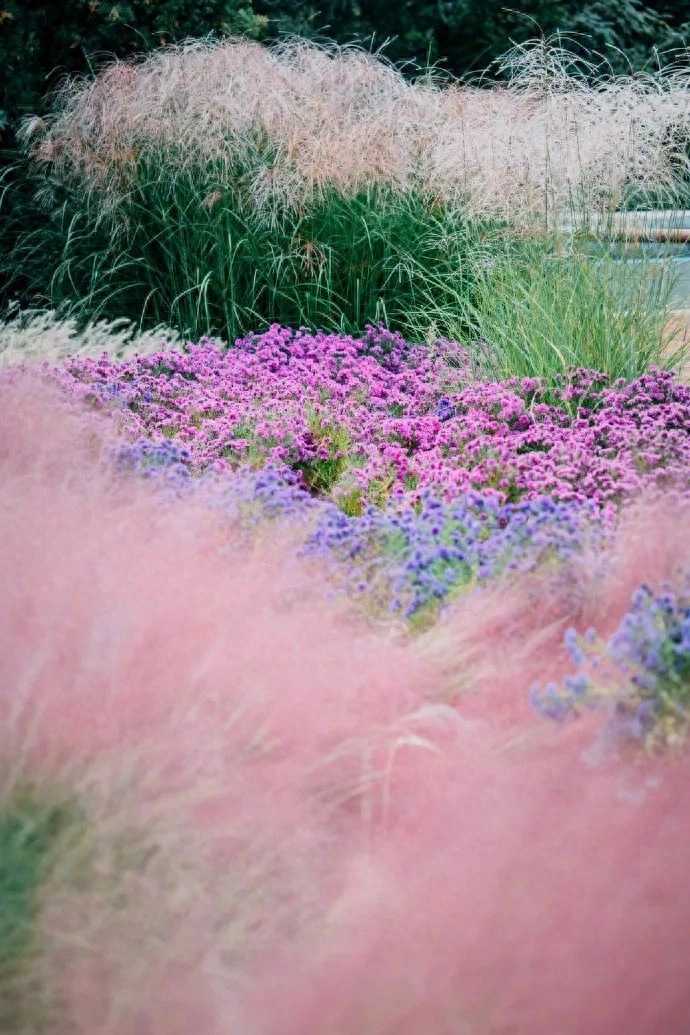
left=21, top=326, right=690, bottom=740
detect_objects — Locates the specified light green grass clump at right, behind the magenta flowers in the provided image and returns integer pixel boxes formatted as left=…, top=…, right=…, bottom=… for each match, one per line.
left=407, top=244, right=680, bottom=380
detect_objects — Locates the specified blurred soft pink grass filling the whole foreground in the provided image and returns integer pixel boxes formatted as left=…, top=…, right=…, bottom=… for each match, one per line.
left=0, top=378, right=690, bottom=1035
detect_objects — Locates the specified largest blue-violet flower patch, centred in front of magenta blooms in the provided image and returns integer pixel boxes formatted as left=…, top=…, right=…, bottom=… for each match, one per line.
left=305, top=493, right=607, bottom=619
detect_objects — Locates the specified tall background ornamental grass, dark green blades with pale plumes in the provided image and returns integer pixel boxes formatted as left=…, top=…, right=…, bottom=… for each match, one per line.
left=9, top=39, right=690, bottom=341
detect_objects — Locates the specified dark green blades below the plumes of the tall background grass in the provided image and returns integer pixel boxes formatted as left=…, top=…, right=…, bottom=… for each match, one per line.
left=5, top=148, right=498, bottom=341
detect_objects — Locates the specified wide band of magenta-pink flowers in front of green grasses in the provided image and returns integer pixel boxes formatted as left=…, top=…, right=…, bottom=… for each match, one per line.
left=54, top=326, right=690, bottom=514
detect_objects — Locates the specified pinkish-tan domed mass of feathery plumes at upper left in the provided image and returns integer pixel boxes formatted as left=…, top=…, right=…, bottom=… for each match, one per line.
left=18, top=39, right=432, bottom=212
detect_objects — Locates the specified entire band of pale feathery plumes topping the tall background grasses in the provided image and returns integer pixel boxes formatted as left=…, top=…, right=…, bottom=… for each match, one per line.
left=24, top=39, right=690, bottom=219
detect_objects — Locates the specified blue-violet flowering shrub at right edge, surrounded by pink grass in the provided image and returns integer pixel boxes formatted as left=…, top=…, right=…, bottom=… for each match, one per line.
left=531, top=585, right=690, bottom=743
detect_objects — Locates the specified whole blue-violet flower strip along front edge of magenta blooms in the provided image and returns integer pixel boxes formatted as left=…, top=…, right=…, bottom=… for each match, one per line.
left=106, top=439, right=607, bottom=620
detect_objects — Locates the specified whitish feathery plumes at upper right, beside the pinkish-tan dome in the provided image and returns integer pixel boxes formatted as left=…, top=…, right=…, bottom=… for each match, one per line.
left=432, top=36, right=690, bottom=222
